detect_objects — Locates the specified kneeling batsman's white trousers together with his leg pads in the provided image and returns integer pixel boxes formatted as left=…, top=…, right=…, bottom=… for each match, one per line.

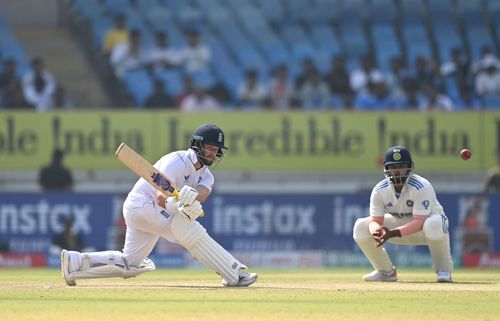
left=72, top=202, right=246, bottom=284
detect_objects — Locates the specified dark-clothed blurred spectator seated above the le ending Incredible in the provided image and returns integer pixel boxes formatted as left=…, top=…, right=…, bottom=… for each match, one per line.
left=325, top=56, right=354, bottom=107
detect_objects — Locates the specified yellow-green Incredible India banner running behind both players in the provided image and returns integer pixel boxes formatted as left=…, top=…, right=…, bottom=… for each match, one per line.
left=0, top=111, right=500, bottom=172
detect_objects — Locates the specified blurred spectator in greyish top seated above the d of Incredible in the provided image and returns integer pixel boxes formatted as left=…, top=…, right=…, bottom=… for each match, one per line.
left=269, top=65, right=295, bottom=110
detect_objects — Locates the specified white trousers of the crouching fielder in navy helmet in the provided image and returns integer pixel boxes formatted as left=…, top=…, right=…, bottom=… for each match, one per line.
left=353, top=214, right=453, bottom=272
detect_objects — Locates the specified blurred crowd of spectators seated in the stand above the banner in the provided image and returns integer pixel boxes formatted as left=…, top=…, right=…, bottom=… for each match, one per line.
left=0, top=0, right=500, bottom=111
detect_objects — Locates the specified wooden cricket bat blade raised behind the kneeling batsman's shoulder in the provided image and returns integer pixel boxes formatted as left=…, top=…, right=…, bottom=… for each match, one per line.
left=115, top=143, right=179, bottom=197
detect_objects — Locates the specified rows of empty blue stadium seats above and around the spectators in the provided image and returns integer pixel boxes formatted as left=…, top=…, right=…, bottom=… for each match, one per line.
left=0, top=0, right=500, bottom=109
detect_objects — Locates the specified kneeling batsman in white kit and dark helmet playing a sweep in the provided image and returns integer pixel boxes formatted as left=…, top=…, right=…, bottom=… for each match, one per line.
left=61, top=124, right=257, bottom=286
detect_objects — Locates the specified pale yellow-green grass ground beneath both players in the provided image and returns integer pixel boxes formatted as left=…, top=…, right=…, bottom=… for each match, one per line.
left=0, top=268, right=500, bottom=321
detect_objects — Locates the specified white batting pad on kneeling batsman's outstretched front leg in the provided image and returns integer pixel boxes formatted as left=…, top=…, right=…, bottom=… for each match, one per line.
left=171, top=215, right=242, bottom=284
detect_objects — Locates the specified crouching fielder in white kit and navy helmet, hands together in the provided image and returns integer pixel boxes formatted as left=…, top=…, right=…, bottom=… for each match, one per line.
left=353, top=146, right=453, bottom=282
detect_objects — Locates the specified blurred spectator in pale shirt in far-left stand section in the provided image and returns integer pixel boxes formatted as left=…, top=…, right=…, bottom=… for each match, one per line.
left=23, top=57, right=55, bottom=111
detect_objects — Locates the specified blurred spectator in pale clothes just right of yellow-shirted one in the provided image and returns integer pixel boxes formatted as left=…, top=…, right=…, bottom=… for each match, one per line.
left=110, top=29, right=146, bottom=77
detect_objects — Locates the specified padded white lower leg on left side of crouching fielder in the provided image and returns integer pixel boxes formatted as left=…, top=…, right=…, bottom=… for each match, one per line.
left=353, top=218, right=393, bottom=272
